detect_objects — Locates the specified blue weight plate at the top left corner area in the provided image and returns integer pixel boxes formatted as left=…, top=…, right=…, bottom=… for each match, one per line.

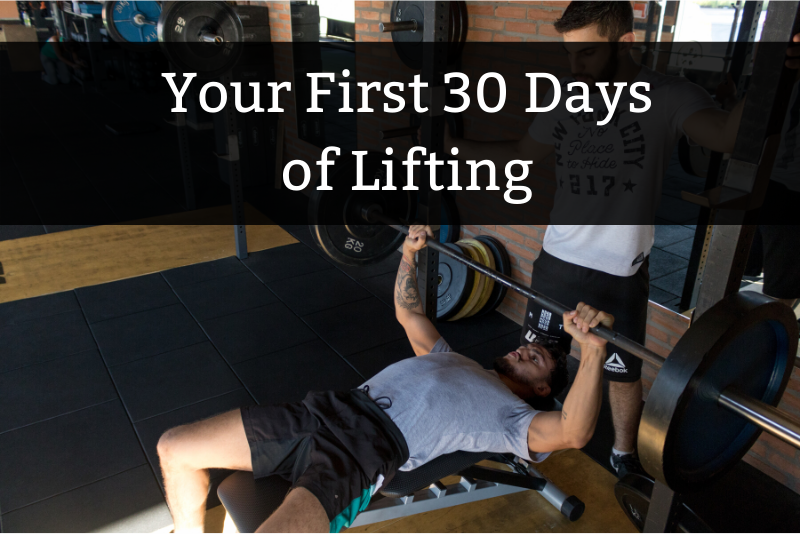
left=102, top=0, right=161, bottom=50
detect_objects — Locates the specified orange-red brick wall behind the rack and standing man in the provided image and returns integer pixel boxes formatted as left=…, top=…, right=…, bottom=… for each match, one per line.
left=356, top=1, right=800, bottom=493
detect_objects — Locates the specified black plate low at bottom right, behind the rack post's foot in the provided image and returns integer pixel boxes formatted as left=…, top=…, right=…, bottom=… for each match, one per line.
left=614, top=473, right=711, bottom=533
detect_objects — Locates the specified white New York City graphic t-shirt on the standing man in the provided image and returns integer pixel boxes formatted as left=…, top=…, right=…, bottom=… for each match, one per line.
left=528, top=67, right=715, bottom=276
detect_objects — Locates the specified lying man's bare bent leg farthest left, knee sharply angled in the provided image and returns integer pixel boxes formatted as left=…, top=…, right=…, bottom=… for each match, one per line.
left=158, top=409, right=252, bottom=532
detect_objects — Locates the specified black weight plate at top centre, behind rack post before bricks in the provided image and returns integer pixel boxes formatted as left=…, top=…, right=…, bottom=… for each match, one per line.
left=391, top=1, right=469, bottom=70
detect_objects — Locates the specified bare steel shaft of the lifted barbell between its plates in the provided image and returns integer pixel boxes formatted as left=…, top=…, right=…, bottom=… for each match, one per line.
left=362, top=206, right=666, bottom=368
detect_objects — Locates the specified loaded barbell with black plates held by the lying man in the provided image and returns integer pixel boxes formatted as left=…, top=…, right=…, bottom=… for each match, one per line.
left=309, top=153, right=800, bottom=492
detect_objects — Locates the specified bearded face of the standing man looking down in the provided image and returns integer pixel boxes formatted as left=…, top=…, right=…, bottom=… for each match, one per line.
left=563, top=25, right=619, bottom=92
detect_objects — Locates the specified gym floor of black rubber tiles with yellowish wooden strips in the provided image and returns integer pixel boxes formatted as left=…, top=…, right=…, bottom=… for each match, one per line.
left=0, top=225, right=800, bottom=532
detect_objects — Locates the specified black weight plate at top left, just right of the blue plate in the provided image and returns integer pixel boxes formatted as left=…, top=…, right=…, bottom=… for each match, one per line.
left=157, top=1, right=244, bottom=78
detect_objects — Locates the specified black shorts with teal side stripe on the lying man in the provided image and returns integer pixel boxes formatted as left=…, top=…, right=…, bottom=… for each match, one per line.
left=241, top=390, right=408, bottom=533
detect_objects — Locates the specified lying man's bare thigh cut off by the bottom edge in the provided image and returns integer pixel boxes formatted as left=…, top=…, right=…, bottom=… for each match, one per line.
left=257, top=487, right=330, bottom=533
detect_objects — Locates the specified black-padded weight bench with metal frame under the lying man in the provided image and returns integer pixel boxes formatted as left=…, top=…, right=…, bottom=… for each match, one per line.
left=217, top=402, right=586, bottom=533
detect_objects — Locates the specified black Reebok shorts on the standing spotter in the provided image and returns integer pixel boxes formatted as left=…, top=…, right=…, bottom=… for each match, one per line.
left=520, top=250, right=650, bottom=383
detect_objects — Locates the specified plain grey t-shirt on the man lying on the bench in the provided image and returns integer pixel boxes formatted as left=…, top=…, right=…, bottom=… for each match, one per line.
left=361, top=338, right=549, bottom=471
